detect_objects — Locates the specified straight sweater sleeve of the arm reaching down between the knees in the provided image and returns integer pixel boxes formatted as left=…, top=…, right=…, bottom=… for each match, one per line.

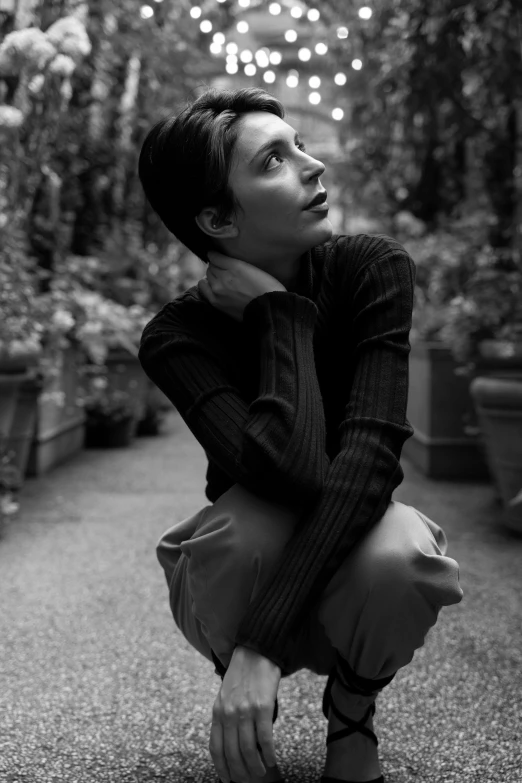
left=235, top=243, right=415, bottom=674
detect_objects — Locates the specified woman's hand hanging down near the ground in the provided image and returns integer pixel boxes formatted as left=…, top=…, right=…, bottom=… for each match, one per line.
left=209, top=646, right=281, bottom=783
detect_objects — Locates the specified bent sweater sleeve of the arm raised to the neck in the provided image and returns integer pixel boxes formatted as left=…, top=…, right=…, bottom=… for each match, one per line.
left=139, top=291, right=327, bottom=506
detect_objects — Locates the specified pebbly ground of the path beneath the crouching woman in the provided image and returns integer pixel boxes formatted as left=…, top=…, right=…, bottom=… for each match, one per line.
left=0, top=411, right=522, bottom=783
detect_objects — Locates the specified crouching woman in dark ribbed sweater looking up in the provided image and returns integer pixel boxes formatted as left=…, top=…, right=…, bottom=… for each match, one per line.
left=139, top=89, right=462, bottom=783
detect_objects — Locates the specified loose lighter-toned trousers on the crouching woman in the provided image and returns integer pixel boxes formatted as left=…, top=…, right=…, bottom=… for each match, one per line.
left=157, top=484, right=463, bottom=679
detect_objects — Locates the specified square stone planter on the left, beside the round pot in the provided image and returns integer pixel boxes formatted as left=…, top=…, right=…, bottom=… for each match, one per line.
left=27, top=346, right=85, bottom=476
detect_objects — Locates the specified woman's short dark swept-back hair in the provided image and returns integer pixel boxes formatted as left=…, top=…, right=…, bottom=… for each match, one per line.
left=138, top=87, right=285, bottom=263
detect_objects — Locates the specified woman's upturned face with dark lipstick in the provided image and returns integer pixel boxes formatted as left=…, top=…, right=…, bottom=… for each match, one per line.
left=224, top=111, right=333, bottom=263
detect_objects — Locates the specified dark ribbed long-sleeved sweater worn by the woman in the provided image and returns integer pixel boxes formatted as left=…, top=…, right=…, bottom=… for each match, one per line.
left=139, top=234, right=415, bottom=676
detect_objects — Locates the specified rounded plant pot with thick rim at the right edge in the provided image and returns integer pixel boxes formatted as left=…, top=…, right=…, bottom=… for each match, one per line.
left=470, top=376, right=522, bottom=534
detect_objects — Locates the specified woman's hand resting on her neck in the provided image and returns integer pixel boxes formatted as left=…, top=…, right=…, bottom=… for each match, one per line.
left=198, top=250, right=286, bottom=321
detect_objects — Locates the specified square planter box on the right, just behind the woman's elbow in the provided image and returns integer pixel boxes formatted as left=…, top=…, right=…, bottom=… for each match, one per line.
left=402, top=340, right=490, bottom=481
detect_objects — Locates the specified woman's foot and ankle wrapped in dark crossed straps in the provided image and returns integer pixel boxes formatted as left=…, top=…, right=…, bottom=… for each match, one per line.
left=323, top=681, right=382, bottom=783
